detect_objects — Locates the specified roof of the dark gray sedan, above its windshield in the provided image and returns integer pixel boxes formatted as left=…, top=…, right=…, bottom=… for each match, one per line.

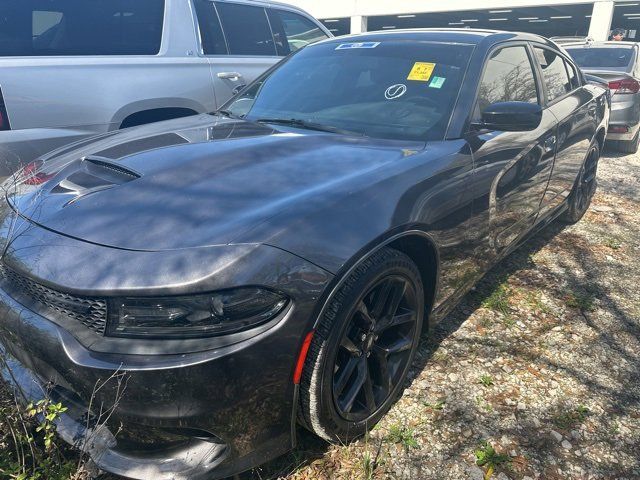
left=312, top=28, right=556, bottom=47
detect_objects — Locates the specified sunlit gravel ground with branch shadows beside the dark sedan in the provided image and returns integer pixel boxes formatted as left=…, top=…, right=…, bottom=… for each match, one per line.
left=242, top=147, right=640, bottom=480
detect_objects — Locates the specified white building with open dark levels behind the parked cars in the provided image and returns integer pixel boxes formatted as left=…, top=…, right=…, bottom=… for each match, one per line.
left=282, top=0, right=640, bottom=41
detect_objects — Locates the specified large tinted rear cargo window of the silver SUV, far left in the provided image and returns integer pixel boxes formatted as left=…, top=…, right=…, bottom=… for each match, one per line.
left=0, top=0, right=164, bottom=57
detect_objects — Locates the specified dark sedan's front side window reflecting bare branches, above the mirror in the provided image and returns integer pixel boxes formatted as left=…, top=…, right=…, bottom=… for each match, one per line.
left=476, top=46, right=538, bottom=118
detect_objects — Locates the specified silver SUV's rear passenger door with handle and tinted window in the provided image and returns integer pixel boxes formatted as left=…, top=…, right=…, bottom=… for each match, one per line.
left=194, top=0, right=281, bottom=106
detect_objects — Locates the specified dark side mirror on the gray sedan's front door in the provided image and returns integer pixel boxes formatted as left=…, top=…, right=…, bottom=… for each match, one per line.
left=474, top=102, right=542, bottom=132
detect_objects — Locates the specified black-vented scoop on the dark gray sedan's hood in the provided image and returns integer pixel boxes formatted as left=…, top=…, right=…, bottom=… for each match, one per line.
left=51, top=156, right=141, bottom=204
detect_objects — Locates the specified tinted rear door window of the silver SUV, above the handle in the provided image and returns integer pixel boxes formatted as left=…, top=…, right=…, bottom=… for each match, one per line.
left=216, top=2, right=277, bottom=56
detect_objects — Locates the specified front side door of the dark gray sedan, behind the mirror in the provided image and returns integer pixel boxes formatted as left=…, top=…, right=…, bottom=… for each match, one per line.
left=467, top=42, right=557, bottom=263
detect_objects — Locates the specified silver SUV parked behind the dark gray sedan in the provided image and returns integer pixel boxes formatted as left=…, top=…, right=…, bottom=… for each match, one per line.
left=0, top=0, right=331, bottom=176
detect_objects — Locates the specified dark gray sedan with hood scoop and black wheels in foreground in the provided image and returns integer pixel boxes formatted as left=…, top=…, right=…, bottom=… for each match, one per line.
left=0, top=30, right=609, bottom=479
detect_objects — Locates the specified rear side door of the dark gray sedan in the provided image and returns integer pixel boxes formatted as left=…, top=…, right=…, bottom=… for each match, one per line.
left=533, top=45, right=598, bottom=215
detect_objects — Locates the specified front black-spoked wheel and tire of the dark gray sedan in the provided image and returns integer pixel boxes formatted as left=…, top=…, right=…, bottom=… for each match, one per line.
left=300, top=248, right=425, bottom=443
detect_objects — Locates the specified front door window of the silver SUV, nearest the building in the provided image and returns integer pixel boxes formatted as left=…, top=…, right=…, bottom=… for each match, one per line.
left=267, top=8, right=327, bottom=55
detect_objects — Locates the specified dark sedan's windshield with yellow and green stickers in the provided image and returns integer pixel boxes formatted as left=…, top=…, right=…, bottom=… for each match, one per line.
left=223, top=40, right=473, bottom=141
